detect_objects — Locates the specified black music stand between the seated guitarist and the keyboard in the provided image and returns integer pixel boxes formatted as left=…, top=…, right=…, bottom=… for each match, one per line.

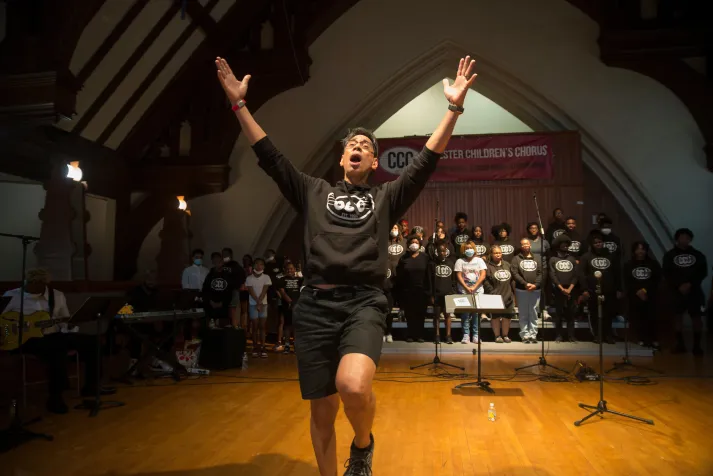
left=72, top=297, right=125, bottom=417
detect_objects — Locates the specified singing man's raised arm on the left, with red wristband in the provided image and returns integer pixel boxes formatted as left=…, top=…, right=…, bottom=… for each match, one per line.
left=215, top=58, right=316, bottom=211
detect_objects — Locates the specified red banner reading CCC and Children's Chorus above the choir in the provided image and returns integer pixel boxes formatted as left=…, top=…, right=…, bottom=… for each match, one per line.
left=374, top=134, right=553, bottom=183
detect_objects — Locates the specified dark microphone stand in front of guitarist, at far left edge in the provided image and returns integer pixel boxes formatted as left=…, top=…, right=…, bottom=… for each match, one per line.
left=0, top=233, right=54, bottom=453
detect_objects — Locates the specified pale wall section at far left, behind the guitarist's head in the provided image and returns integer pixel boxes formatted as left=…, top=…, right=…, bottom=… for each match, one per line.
left=0, top=179, right=45, bottom=281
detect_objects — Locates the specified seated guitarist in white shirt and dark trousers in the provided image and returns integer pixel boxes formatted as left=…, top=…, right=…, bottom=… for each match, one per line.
left=3, top=269, right=116, bottom=414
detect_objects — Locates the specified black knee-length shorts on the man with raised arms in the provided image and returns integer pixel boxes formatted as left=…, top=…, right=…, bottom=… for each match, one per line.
left=294, top=286, right=387, bottom=400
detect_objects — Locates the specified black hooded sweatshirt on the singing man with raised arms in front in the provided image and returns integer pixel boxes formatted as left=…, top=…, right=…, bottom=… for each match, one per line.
left=253, top=137, right=440, bottom=288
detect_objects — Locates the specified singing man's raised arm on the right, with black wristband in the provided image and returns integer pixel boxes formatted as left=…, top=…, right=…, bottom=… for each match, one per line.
left=391, top=56, right=478, bottom=216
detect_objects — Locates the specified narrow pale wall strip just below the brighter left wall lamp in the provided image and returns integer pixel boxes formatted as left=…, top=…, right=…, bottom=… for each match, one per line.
left=84, top=194, right=116, bottom=281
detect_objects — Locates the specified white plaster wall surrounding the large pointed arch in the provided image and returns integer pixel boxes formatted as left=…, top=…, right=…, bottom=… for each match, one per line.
left=191, top=0, right=713, bottom=290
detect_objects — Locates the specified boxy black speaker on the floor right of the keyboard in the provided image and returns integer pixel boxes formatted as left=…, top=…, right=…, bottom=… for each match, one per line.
left=199, top=328, right=247, bottom=370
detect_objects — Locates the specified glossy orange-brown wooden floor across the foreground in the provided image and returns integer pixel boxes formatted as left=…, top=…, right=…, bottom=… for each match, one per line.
left=0, top=355, right=713, bottom=476
